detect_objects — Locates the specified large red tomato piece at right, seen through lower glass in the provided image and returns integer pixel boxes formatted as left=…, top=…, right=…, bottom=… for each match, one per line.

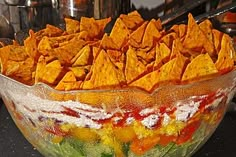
left=176, top=121, right=201, bottom=144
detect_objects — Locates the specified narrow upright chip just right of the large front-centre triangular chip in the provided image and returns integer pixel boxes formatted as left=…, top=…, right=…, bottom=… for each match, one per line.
left=125, top=48, right=147, bottom=84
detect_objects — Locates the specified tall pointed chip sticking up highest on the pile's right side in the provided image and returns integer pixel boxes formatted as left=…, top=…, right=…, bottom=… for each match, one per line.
left=183, top=14, right=215, bottom=56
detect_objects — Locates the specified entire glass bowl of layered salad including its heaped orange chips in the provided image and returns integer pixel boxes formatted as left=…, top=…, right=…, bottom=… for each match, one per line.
left=0, top=11, right=236, bottom=157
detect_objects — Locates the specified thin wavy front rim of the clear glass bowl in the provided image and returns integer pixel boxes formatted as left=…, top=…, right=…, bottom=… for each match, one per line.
left=0, top=68, right=236, bottom=95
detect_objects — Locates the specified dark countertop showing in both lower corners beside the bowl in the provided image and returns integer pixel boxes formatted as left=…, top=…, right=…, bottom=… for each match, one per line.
left=0, top=100, right=236, bottom=157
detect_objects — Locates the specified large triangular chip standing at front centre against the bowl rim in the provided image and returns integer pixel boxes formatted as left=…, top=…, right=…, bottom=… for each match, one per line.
left=82, top=50, right=125, bottom=89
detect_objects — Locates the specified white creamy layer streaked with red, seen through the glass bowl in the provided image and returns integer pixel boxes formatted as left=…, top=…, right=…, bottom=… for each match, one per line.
left=6, top=91, right=226, bottom=129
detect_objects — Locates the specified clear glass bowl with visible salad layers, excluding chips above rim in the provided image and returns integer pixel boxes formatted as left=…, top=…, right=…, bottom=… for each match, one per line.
left=0, top=71, right=236, bottom=157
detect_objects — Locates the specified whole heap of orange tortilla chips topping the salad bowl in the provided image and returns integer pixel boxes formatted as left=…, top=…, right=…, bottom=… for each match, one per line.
left=0, top=11, right=235, bottom=92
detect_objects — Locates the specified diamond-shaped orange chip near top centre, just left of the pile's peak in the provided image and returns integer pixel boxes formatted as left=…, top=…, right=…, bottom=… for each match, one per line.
left=110, top=18, right=130, bottom=49
